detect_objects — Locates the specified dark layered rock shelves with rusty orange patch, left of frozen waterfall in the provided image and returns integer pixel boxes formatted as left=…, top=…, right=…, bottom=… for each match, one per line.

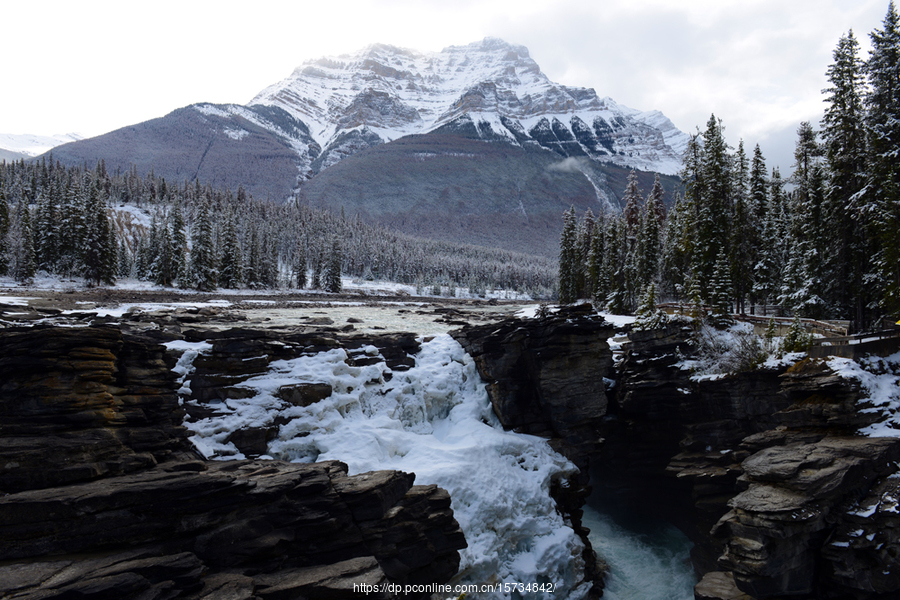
left=0, top=327, right=465, bottom=600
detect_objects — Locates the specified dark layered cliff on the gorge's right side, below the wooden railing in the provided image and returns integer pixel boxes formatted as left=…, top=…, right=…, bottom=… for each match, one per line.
left=598, top=325, right=900, bottom=600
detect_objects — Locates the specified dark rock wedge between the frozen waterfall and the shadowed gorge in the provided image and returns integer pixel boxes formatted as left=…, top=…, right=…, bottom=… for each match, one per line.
left=453, top=305, right=613, bottom=594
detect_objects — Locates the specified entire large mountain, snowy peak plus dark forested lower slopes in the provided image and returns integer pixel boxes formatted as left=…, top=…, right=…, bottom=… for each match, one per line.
left=40, top=38, right=688, bottom=256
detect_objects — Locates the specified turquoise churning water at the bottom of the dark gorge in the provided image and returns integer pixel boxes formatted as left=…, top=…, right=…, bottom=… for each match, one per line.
left=583, top=492, right=697, bottom=600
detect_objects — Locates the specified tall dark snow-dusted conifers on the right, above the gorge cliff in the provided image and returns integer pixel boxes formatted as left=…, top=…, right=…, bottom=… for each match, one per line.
left=559, top=1, right=900, bottom=328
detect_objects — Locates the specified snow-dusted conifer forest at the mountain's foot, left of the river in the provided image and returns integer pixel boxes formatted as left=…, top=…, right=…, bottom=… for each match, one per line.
left=0, top=158, right=556, bottom=298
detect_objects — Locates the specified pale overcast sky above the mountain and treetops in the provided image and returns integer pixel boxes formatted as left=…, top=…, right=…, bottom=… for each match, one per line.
left=0, top=0, right=888, bottom=171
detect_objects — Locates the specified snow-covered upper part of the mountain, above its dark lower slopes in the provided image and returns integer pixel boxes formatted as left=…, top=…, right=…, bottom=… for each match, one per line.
left=250, top=38, right=688, bottom=176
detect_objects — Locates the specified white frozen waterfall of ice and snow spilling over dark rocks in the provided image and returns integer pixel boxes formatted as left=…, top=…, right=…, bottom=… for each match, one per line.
left=180, top=335, right=587, bottom=599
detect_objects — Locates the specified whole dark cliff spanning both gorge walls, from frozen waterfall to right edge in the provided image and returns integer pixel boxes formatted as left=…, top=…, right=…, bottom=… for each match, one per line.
left=456, top=314, right=900, bottom=600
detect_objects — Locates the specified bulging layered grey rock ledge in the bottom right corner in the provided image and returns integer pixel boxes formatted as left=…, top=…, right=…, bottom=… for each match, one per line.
left=715, top=436, right=900, bottom=598
